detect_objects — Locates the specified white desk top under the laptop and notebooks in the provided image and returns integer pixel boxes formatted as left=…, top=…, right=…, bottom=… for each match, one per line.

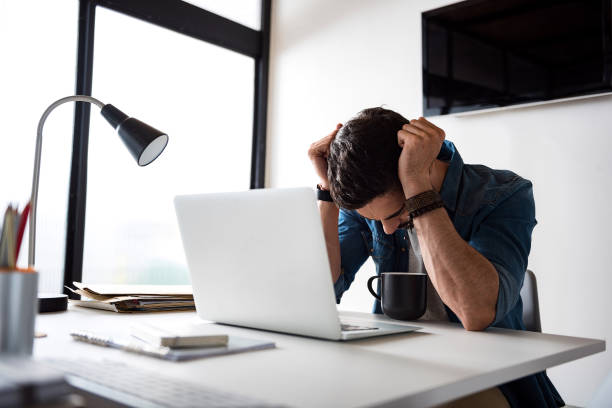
left=34, top=306, right=605, bottom=407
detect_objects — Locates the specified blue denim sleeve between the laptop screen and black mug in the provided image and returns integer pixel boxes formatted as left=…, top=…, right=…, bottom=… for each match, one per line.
left=334, top=210, right=371, bottom=303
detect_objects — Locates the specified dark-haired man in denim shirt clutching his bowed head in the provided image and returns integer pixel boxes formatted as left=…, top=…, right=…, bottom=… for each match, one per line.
left=308, top=108, right=564, bottom=407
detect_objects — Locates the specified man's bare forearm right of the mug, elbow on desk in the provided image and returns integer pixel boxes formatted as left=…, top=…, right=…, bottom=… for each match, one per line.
left=414, top=208, right=499, bottom=330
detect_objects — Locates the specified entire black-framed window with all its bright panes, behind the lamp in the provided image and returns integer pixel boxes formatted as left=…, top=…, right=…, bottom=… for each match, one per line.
left=0, top=0, right=271, bottom=292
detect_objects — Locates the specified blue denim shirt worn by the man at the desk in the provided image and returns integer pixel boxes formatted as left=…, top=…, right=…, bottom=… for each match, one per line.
left=334, top=140, right=563, bottom=407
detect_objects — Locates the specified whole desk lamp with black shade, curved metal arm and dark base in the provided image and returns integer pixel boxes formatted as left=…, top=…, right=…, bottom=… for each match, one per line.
left=28, top=95, right=168, bottom=312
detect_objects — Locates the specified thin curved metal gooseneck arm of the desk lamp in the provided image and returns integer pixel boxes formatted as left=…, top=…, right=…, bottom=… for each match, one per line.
left=28, top=95, right=104, bottom=268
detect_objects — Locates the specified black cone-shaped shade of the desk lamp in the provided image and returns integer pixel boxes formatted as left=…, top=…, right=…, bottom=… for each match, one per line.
left=100, top=104, right=168, bottom=166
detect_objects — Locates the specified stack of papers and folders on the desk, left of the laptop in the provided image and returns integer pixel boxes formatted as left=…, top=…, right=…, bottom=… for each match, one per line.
left=68, top=282, right=195, bottom=313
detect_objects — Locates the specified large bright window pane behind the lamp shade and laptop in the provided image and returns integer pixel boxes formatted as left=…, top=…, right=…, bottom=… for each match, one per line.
left=83, top=8, right=255, bottom=284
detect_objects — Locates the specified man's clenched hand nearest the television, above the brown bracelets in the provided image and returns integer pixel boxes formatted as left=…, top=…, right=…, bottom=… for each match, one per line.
left=397, top=117, right=445, bottom=198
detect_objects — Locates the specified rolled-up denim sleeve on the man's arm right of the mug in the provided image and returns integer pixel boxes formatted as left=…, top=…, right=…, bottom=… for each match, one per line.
left=469, top=180, right=537, bottom=325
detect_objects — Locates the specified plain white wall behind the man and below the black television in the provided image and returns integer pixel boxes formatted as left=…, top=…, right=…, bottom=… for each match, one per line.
left=267, top=0, right=612, bottom=405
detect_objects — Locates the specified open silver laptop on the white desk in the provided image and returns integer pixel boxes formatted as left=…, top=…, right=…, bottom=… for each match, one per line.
left=174, top=188, right=420, bottom=340
